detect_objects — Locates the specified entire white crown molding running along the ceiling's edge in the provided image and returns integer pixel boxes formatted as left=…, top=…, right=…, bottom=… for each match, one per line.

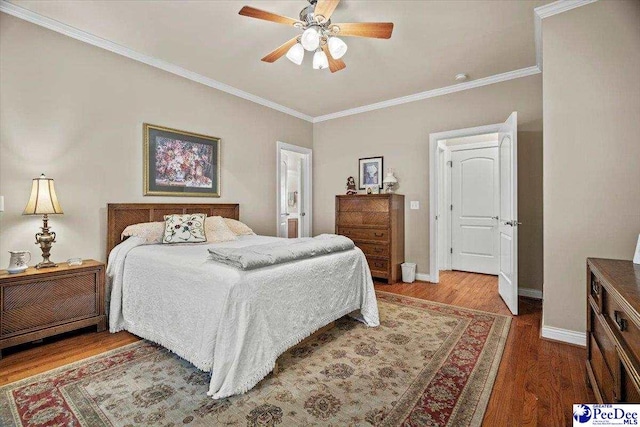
left=0, top=0, right=597, bottom=123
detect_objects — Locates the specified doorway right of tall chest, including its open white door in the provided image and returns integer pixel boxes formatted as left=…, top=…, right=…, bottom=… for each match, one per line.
left=429, top=112, right=519, bottom=314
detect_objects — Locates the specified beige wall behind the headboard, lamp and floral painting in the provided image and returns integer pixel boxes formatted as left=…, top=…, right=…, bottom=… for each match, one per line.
left=0, top=14, right=313, bottom=268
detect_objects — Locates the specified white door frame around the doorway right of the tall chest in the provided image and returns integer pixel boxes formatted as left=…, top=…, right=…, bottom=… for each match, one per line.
left=428, top=123, right=502, bottom=283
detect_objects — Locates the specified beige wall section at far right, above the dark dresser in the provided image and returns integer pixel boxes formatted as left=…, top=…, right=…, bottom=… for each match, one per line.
left=543, top=1, right=640, bottom=332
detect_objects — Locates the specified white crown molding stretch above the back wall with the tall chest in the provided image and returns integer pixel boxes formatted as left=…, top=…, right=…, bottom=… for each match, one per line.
left=313, top=65, right=540, bottom=123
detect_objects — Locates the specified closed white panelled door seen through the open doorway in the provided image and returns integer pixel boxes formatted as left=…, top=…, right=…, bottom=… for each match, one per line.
left=450, top=147, right=500, bottom=275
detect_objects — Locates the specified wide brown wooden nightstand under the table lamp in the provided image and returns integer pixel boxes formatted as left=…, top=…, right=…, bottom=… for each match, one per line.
left=0, top=259, right=107, bottom=358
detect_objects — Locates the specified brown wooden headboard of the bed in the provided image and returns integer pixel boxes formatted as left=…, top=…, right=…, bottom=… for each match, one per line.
left=107, top=203, right=240, bottom=256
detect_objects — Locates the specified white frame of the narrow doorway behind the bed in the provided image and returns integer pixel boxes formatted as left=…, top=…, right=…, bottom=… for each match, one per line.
left=276, top=141, right=313, bottom=237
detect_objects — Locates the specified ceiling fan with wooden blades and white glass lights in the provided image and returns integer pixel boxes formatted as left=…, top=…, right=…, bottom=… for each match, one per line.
left=239, top=0, right=393, bottom=73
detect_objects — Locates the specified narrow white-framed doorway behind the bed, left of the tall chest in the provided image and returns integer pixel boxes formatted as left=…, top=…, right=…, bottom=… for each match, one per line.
left=276, top=142, right=312, bottom=238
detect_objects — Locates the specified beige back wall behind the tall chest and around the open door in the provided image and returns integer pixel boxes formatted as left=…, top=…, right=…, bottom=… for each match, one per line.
left=313, top=75, right=542, bottom=289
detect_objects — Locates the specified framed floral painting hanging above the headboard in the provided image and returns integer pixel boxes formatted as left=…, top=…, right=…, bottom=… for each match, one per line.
left=143, top=123, right=221, bottom=197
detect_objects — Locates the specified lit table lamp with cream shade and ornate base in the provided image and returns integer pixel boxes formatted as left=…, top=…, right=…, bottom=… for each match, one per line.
left=22, top=174, right=62, bottom=268
